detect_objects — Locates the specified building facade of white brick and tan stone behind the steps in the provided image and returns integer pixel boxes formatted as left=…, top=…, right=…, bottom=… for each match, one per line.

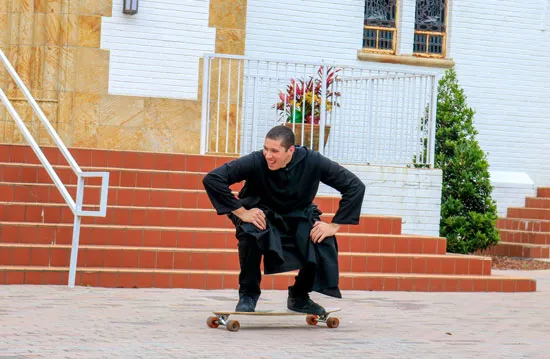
left=0, top=0, right=550, bottom=235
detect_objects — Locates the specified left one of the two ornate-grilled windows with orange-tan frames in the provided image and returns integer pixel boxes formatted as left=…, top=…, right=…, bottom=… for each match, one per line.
left=363, top=0, right=398, bottom=54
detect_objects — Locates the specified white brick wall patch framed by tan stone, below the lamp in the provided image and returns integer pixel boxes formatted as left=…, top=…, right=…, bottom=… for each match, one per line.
left=101, top=0, right=216, bottom=100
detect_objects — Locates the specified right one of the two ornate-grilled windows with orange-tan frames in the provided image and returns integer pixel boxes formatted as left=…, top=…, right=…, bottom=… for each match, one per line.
left=413, top=0, right=447, bottom=57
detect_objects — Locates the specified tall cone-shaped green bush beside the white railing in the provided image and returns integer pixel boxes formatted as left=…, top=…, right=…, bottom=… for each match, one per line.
left=435, top=69, right=499, bottom=254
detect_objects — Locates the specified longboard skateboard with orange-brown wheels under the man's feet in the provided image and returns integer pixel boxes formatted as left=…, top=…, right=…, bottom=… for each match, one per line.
left=206, top=308, right=342, bottom=332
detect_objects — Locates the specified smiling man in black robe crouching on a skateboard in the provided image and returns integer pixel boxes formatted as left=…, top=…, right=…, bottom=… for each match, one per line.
left=203, top=126, right=365, bottom=314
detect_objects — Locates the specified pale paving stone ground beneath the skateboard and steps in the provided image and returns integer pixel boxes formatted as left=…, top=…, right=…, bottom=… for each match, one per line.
left=0, top=270, right=550, bottom=359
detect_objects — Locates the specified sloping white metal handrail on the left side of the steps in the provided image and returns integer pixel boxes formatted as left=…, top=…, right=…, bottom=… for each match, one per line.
left=0, top=50, right=109, bottom=288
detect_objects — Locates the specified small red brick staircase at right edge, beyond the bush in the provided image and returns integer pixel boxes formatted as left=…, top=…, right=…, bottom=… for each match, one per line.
left=483, top=187, right=550, bottom=259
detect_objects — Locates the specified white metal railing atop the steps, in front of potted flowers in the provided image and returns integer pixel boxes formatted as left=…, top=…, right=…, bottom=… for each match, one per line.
left=201, top=54, right=437, bottom=166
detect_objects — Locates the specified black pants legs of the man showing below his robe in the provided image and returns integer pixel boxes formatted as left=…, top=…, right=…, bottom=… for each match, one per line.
left=238, top=235, right=315, bottom=296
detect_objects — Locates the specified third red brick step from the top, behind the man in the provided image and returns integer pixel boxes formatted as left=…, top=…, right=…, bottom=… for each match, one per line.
left=0, top=182, right=354, bottom=217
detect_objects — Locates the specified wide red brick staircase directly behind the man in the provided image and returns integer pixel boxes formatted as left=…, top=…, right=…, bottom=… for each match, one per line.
left=0, top=145, right=536, bottom=292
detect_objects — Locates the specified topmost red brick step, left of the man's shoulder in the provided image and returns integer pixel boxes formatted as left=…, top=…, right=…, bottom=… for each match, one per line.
left=0, top=144, right=236, bottom=172
